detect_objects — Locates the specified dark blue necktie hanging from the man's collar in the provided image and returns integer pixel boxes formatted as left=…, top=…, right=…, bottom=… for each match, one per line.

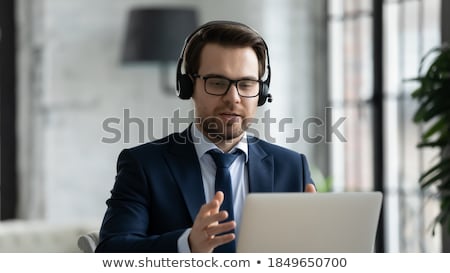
left=208, top=150, right=239, bottom=252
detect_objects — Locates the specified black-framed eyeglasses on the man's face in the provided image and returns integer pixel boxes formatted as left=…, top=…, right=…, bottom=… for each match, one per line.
left=192, top=74, right=261, bottom=98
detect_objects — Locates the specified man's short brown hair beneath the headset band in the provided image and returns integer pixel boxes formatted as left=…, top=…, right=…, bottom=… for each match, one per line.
left=184, top=22, right=267, bottom=78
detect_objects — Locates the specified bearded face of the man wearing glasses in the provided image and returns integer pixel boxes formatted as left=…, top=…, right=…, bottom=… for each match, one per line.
left=192, top=43, right=258, bottom=142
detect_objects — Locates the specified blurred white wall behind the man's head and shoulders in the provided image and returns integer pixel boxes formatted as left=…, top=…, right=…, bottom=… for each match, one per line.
left=18, top=0, right=325, bottom=222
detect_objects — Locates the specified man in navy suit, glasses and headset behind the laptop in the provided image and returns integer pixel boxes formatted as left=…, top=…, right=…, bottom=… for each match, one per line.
left=96, top=21, right=316, bottom=252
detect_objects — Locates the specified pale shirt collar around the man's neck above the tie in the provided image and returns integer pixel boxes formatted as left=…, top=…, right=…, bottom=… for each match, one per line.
left=191, top=124, right=248, bottom=162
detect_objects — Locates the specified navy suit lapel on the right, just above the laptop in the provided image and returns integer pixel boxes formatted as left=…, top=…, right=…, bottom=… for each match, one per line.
left=248, top=137, right=274, bottom=192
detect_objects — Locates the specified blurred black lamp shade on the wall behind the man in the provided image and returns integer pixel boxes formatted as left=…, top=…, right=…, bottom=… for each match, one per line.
left=122, top=8, right=197, bottom=63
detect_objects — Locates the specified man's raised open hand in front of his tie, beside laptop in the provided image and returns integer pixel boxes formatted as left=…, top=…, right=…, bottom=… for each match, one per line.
left=188, top=191, right=236, bottom=252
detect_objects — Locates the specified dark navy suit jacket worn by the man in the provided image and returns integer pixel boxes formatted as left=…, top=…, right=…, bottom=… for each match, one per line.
left=96, top=126, right=313, bottom=253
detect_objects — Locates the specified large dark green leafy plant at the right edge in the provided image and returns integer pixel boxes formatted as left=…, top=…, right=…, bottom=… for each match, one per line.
left=412, top=45, right=450, bottom=234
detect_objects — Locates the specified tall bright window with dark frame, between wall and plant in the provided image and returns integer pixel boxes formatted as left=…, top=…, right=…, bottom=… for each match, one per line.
left=328, top=0, right=441, bottom=252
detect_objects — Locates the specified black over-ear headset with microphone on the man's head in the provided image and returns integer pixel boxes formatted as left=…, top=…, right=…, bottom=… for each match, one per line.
left=176, top=21, right=272, bottom=106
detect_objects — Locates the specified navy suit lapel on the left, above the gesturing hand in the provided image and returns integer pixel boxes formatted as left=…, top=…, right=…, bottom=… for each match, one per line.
left=165, top=128, right=206, bottom=220
